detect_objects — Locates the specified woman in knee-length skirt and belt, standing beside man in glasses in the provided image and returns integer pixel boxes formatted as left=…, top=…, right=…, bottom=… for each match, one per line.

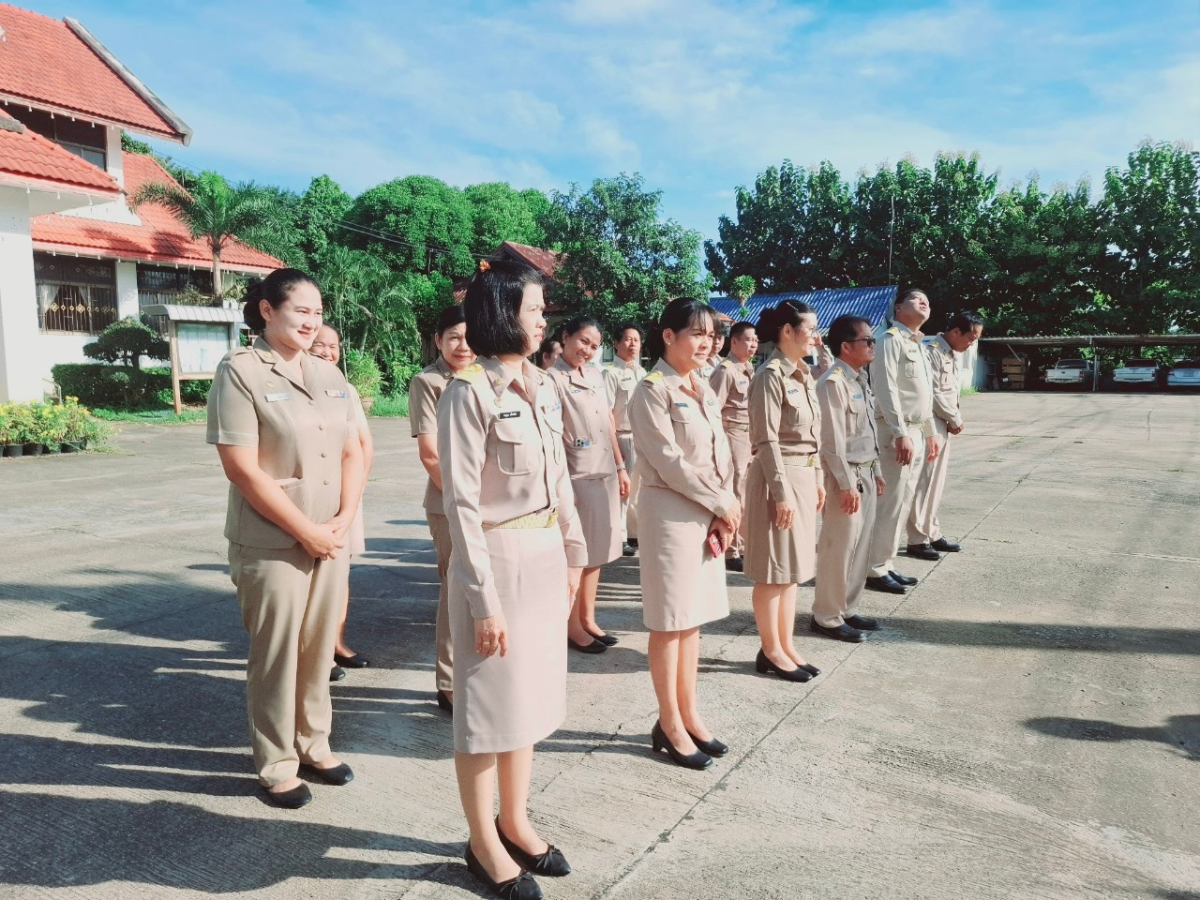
left=744, top=300, right=824, bottom=682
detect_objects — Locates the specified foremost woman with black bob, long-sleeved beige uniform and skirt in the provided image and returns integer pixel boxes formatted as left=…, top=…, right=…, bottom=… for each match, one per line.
left=438, top=260, right=587, bottom=898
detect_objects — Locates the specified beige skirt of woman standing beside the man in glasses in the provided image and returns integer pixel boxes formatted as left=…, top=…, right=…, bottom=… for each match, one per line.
left=742, top=456, right=817, bottom=584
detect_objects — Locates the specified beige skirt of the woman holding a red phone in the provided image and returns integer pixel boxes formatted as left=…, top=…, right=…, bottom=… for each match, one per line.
left=637, top=484, right=730, bottom=631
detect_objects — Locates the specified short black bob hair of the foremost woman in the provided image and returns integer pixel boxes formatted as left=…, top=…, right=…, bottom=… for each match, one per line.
left=462, top=259, right=546, bottom=356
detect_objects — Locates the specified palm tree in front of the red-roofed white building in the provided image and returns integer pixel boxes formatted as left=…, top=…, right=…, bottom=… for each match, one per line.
left=131, top=172, right=277, bottom=301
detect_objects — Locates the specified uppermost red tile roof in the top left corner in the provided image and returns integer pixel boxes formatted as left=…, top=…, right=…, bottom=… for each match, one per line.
left=0, top=4, right=191, bottom=143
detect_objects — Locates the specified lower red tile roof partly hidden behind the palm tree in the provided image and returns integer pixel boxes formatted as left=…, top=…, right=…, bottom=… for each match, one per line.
left=32, top=154, right=283, bottom=272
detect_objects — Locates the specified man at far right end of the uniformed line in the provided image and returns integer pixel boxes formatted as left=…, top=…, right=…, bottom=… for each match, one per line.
left=907, top=311, right=983, bottom=556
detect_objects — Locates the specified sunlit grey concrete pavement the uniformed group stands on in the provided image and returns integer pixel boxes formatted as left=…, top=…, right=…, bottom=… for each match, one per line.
left=0, top=394, right=1200, bottom=900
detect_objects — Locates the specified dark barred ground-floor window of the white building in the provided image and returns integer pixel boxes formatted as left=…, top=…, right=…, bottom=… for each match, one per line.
left=34, top=253, right=116, bottom=335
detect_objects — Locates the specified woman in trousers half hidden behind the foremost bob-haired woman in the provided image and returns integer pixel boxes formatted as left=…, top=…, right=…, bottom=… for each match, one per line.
left=408, top=304, right=475, bottom=713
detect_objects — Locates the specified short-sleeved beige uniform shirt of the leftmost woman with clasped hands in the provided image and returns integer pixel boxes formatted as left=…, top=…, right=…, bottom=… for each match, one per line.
left=206, top=337, right=358, bottom=550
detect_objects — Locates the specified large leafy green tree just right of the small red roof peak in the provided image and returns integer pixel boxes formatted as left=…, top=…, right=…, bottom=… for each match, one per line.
left=546, top=174, right=708, bottom=328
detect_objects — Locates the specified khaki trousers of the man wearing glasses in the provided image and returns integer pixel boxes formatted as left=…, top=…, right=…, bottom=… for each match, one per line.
left=812, top=464, right=877, bottom=628
